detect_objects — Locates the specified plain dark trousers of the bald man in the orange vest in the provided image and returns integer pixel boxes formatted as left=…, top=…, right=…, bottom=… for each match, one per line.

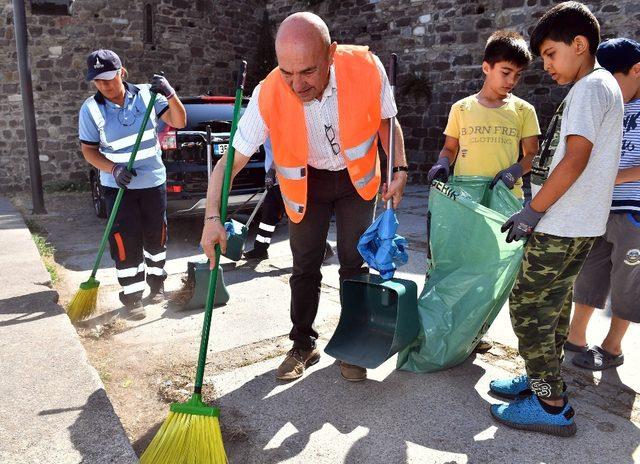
left=289, top=167, right=375, bottom=350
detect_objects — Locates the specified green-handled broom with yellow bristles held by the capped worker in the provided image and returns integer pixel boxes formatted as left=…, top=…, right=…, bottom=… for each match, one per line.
left=67, top=92, right=157, bottom=322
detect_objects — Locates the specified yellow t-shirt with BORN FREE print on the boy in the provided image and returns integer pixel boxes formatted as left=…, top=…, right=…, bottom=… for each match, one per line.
left=444, top=95, right=540, bottom=198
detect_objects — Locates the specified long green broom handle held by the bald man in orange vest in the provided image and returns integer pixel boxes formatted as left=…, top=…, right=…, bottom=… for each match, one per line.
left=193, top=61, right=247, bottom=395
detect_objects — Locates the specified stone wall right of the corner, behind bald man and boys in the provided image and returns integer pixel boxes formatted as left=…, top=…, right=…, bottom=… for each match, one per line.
left=267, top=0, right=640, bottom=181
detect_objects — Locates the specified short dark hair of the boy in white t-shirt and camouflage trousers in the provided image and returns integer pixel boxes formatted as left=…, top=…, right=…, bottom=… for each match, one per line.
left=530, top=2, right=600, bottom=56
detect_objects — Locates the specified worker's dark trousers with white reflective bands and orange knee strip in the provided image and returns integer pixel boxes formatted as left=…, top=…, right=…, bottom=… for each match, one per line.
left=104, top=184, right=167, bottom=304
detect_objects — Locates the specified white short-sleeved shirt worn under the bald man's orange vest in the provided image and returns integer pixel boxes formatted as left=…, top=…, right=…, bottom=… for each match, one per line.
left=233, top=55, right=398, bottom=171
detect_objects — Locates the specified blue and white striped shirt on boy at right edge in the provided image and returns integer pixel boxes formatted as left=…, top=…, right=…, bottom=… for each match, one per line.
left=611, top=98, right=640, bottom=213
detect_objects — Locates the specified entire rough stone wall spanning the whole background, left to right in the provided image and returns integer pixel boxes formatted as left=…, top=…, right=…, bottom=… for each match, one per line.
left=0, top=0, right=640, bottom=192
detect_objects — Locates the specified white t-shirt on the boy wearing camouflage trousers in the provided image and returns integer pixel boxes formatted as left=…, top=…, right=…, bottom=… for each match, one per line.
left=531, top=69, right=624, bottom=237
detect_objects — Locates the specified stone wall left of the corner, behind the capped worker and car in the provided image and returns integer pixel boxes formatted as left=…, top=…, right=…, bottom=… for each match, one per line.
left=0, top=0, right=270, bottom=192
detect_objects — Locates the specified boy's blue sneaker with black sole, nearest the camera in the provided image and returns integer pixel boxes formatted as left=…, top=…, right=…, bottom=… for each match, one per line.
left=491, top=395, right=577, bottom=437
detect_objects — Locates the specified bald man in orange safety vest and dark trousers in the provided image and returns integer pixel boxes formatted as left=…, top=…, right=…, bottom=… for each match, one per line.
left=201, top=13, right=407, bottom=381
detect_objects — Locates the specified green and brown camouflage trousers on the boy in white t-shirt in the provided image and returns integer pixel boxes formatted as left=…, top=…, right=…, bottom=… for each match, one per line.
left=509, top=232, right=595, bottom=399
